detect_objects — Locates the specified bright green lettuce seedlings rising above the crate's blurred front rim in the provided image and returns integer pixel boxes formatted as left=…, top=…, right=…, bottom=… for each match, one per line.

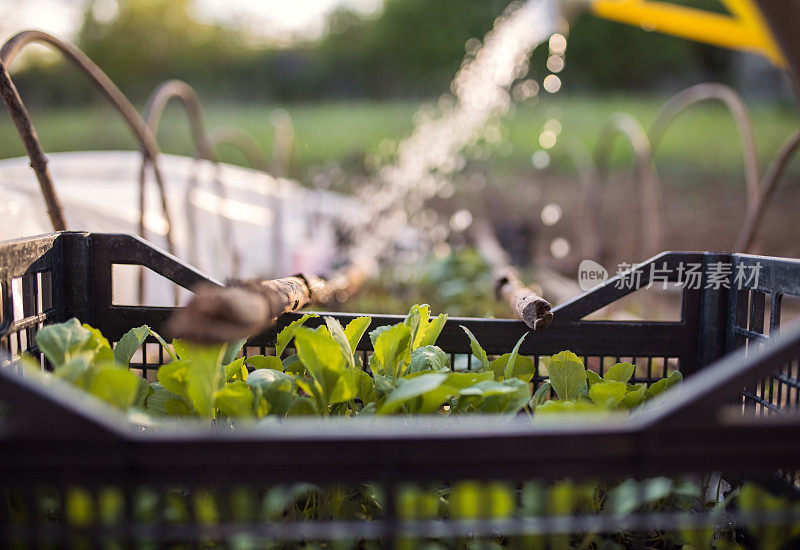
left=31, top=305, right=681, bottom=420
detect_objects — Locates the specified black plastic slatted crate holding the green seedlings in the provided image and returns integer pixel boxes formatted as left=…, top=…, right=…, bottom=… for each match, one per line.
left=0, top=232, right=800, bottom=548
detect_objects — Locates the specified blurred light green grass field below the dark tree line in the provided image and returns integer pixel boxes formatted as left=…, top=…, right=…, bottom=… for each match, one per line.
left=0, top=96, right=800, bottom=179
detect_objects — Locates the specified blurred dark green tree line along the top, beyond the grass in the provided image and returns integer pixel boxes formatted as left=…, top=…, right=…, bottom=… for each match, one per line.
left=9, top=0, right=735, bottom=105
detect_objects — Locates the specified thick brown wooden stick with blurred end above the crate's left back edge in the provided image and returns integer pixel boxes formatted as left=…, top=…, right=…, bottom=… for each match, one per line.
left=166, top=267, right=365, bottom=343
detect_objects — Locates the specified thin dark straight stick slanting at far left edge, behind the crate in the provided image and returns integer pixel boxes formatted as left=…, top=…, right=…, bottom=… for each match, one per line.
left=0, top=61, right=67, bottom=231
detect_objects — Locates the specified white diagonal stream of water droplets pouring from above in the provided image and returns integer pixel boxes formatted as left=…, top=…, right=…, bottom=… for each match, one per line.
left=344, top=1, right=566, bottom=266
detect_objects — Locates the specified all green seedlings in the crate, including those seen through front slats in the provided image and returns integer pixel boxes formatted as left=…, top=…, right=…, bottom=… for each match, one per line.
left=23, top=316, right=776, bottom=548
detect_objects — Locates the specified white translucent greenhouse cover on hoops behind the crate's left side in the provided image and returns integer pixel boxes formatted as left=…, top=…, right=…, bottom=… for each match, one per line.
left=0, top=151, right=364, bottom=305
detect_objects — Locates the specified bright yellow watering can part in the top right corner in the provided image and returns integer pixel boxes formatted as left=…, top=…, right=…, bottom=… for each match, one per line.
left=592, top=0, right=785, bottom=67
